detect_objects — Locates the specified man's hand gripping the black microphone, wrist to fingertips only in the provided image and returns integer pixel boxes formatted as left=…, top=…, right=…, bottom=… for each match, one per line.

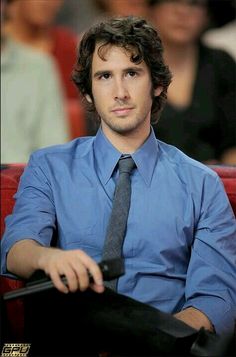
left=38, top=248, right=104, bottom=293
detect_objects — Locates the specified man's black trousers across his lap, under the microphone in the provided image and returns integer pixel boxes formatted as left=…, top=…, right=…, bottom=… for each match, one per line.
left=23, top=289, right=228, bottom=356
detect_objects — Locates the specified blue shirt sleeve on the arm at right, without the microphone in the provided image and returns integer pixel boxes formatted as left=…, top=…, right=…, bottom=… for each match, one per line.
left=183, top=171, right=236, bottom=334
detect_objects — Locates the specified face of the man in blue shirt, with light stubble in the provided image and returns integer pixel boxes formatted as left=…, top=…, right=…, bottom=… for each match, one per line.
left=87, top=44, right=160, bottom=135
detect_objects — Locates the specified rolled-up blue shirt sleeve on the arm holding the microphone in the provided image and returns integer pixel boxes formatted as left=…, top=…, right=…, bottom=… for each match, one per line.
left=1, top=154, right=56, bottom=278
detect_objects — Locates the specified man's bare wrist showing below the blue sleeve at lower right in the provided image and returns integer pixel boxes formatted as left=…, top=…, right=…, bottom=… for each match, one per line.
left=174, top=307, right=214, bottom=332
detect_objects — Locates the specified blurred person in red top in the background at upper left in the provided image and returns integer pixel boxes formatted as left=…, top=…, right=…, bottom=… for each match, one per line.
left=5, top=0, right=78, bottom=98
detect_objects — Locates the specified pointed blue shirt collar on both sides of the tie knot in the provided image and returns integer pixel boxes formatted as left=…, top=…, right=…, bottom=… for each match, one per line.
left=94, top=128, right=159, bottom=186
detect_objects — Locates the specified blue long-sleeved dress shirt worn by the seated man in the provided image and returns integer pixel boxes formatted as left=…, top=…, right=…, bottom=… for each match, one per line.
left=1, top=129, right=236, bottom=333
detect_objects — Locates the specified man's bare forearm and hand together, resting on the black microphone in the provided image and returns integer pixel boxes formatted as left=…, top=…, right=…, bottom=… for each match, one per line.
left=7, top=239, right=104, bottom=293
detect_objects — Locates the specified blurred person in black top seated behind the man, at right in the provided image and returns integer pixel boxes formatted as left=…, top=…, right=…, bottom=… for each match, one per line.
left=150, top=0, right=236, bottom=164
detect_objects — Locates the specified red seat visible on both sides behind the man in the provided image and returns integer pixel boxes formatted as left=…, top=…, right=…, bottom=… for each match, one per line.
left=0, top=164, right=236, bottom=342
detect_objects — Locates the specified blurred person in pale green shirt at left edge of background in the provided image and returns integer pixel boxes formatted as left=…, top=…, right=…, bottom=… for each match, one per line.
left=1, top=1, right=68, bottom=163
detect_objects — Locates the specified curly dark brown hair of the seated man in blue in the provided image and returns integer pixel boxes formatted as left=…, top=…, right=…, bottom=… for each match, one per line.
left=72, top=16, right=172, bottom=123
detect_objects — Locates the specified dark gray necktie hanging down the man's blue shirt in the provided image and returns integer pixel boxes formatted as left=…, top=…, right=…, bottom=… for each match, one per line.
left=102, top=156, right=135, bottom=290
